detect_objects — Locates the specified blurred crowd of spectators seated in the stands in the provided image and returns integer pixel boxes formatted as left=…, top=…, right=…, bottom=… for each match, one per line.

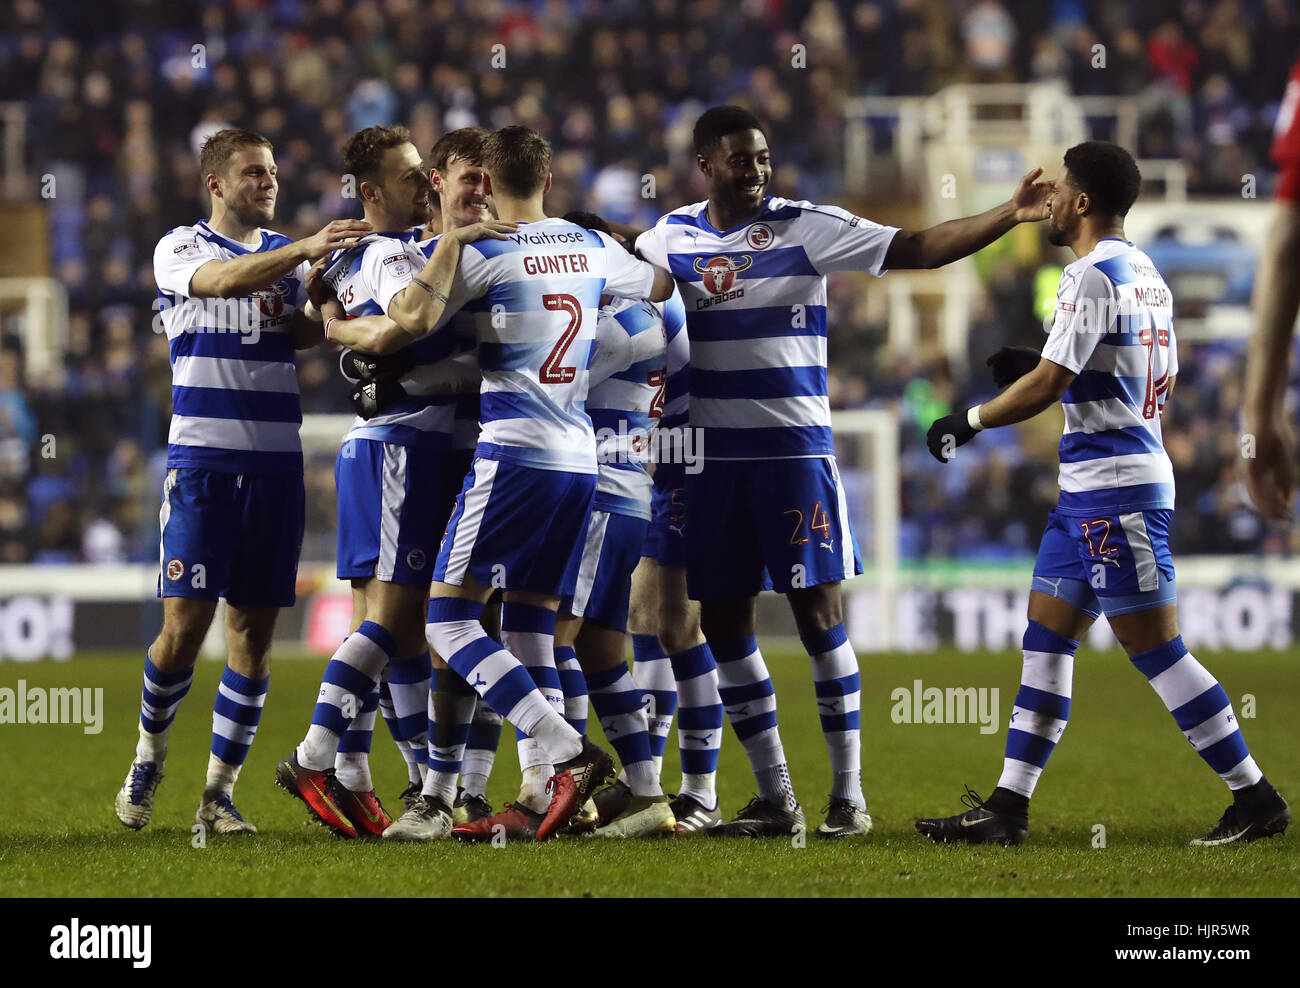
left=0, top=0, right=1300, bottom=563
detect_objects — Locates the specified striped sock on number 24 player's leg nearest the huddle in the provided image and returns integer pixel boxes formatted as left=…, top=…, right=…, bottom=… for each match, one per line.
left=710, top=636, right=798, bottom=809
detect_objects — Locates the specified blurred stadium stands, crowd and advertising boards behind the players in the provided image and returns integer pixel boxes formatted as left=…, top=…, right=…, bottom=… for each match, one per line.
left=0, top=0, right=1300, bottom=658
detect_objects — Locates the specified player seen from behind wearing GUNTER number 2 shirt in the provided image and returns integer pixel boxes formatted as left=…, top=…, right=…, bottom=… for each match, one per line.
left=326, top=126, right=672, bottom=840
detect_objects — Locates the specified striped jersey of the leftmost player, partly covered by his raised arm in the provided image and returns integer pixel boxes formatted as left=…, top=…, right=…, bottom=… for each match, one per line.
left=153, top=220, right=311, bottom=476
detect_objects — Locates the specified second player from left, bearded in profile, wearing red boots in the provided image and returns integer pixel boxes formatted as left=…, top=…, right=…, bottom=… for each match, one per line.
left=276, top=126, right=457, bottom=837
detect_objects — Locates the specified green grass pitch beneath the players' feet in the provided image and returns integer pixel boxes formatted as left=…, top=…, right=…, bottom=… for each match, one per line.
left=0, top=650, right=1300, bottom=897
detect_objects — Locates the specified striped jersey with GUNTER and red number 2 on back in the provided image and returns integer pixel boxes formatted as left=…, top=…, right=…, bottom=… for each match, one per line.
left=432, top=217, right=654, bottom=473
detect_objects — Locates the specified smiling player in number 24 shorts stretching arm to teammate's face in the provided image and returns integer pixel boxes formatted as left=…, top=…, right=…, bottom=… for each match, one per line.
left=637, top=107, right=1049, bottom=837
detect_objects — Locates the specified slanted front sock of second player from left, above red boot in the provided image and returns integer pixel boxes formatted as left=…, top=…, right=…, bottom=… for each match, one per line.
left=298, top=621, right=397, bottom=772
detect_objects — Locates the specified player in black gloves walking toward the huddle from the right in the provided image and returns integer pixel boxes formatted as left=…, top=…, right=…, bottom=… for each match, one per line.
left=917, top=140, right=1291, bottom=846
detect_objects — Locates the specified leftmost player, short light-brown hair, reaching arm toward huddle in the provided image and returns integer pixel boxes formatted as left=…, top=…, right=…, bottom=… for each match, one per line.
left=114, top=129, right=371, bottom=833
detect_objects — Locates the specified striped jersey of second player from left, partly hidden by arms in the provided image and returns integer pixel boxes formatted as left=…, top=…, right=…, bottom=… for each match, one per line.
left=325, top=231, right=478, bottom=452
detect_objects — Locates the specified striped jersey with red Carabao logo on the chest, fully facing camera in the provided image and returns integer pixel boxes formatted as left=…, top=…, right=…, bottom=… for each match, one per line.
left=637, top=196, right=898, bottom=460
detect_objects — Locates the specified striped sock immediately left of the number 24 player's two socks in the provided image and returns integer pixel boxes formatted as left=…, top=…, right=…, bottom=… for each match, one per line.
left=655, top=644, right=723, bottom=810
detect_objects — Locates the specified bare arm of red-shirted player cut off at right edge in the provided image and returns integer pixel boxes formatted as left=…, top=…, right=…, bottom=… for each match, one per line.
left=1245, top=202, right=1300, bottom=521
